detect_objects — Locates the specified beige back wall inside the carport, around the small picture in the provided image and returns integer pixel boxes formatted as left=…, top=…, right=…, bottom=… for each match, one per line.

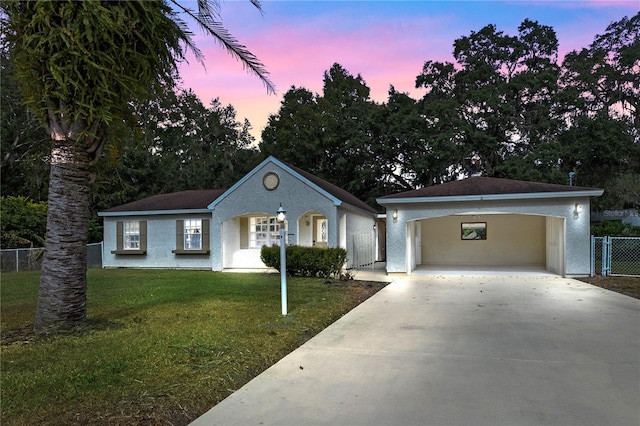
left=422, top=214, right=546, bottom=266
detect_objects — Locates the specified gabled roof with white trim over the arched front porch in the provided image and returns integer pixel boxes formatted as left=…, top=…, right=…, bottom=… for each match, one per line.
left=209, top=156, right=378, bottom=214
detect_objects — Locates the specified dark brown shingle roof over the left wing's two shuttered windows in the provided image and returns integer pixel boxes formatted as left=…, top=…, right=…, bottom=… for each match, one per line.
left=105, top=189, right=226, bottom=213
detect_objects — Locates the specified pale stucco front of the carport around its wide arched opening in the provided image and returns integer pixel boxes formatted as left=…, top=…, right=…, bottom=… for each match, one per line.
left=386, top=197, right=590, bottom=276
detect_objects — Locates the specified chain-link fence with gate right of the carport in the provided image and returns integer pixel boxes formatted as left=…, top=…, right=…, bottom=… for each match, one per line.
left=591, top=236, right=640, bottom=277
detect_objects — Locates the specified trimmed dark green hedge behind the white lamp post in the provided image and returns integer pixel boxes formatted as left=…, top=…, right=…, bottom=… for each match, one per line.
left=260, top=246, right=347, bottom=278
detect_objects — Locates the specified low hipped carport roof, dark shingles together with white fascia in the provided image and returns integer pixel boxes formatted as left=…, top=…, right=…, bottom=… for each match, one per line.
left=377, top=177, right=603, bottom=204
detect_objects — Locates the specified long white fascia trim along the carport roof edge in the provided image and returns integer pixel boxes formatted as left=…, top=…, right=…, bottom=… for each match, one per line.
left=376, top=189, right=604, bottom=205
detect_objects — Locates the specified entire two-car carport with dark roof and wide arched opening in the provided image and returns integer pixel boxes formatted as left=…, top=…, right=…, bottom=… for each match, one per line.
left=378, top=177, right=603, bottom=276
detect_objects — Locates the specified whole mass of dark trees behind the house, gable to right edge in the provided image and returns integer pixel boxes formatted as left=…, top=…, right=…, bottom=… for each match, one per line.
left=260, top=14, right=640, bottom=208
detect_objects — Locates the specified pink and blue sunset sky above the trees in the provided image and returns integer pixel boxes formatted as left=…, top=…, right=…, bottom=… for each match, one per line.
left=180, top=0, right=640, bottom=142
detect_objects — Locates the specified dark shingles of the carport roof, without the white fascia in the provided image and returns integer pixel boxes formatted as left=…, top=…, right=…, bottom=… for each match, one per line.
left=380, top=177, right=596, bottom=200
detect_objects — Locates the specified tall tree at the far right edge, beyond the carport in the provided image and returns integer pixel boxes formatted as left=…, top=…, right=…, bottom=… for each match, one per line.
left=548, top=13, right=640, bottom=208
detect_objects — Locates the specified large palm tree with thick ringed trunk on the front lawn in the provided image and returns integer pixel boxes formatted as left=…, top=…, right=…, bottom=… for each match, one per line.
left=1, top=0, right=274, bottom=330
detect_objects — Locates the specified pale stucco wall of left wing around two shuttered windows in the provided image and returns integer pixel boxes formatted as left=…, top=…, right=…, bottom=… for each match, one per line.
left=102, top=214, right=212, bottom=269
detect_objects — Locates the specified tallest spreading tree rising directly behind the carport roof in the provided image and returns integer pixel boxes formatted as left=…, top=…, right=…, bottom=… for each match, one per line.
left=416, top=19, right=559, bottom=177
